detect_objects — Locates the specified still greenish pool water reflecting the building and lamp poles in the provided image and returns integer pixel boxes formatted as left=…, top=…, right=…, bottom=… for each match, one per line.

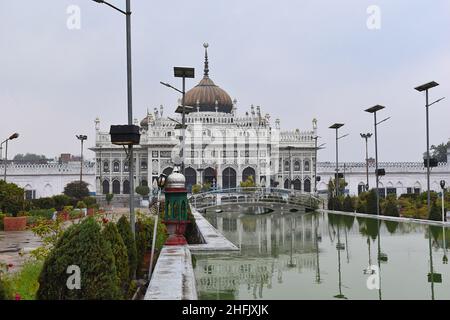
left=194, top=207, right=450, bottom=299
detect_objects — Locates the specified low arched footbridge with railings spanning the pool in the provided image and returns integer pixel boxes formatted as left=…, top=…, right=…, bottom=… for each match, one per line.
left=189, top=187, right=322, bottom=209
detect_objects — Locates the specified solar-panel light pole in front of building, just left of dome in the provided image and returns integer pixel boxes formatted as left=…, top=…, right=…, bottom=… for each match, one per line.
left=160, top=67, right=195, bottom=175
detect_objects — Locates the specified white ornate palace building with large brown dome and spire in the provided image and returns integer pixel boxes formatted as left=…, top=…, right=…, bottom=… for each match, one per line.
left=91, top=45, right=317, bottom=197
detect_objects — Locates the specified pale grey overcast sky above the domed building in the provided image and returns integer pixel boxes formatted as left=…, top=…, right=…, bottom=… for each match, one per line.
left=0, top=0, right=450, bottom=161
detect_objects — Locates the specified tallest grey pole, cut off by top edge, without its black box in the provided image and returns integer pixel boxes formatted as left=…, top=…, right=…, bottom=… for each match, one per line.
left=93, top=0, right=136, bottom=234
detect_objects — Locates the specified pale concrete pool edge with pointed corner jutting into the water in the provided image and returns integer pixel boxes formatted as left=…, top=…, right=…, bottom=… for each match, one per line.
left=144, top=208, right=239, bottom=300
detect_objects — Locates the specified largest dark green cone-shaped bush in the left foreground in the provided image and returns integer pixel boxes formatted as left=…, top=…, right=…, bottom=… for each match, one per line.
left=37, top=218, right=121, bottom=300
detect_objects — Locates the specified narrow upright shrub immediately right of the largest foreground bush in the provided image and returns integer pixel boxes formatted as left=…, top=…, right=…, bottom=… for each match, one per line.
left=102, top=222, right=130, bottom=299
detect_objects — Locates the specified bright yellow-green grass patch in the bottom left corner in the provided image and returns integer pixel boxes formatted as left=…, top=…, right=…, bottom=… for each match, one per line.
left=5, top=260, right=43, bottom=300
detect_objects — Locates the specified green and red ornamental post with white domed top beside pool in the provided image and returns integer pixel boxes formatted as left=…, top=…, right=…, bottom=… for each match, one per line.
left=163, top=170, right=189, bottom=245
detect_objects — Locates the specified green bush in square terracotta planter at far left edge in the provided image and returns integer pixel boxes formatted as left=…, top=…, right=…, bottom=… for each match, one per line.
left=0, top=180, right=27, bottom=231
